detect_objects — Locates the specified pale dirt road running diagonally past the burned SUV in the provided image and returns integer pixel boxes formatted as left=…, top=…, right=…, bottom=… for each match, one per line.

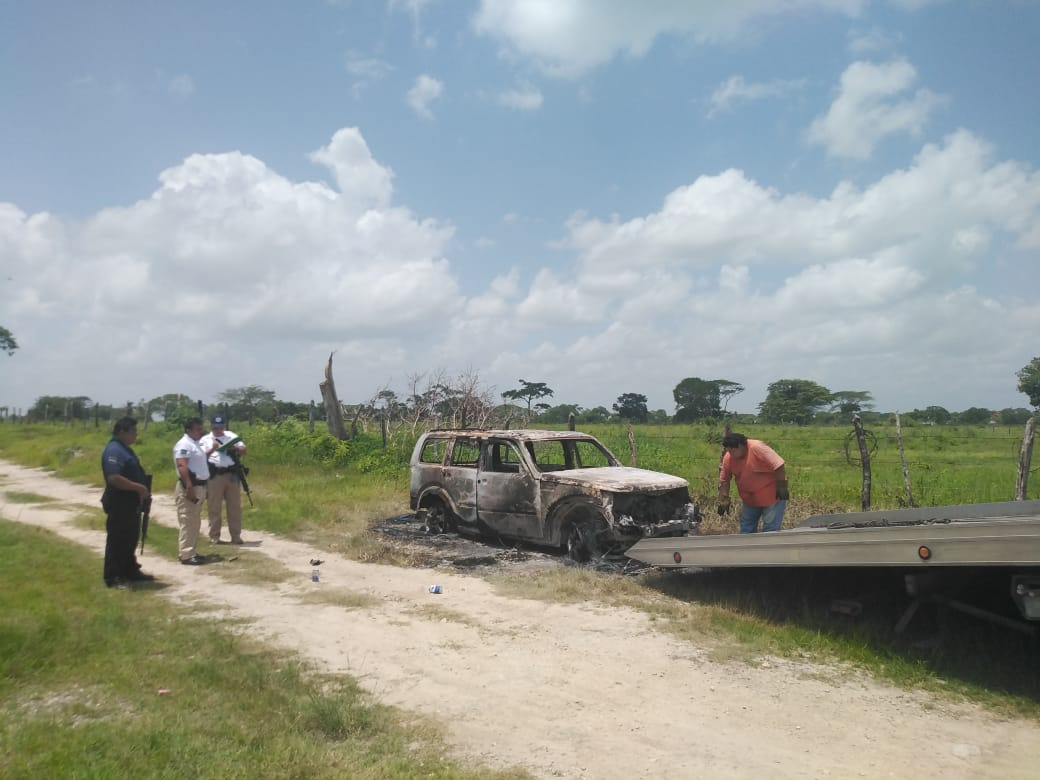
left=0, top=461, right=1040, bottom=780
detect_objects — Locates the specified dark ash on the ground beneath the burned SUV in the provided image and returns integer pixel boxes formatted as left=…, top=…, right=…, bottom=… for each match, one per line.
left=370, top=513, right=646, bottom=574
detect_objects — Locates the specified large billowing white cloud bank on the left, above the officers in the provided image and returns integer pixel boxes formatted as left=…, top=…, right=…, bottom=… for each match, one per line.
left=0, top=129, right=462, bottom=402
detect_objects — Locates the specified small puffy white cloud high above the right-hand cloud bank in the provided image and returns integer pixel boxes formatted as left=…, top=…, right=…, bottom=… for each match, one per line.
left=808, top=59, right=945, bottom=159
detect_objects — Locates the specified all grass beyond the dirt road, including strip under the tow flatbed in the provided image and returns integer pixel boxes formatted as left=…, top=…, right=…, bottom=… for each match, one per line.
left=0, top=423, right=1040, bottom=728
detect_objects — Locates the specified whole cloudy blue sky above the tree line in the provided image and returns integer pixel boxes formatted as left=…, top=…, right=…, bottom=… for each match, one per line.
left=0, top=0, right=1040, bottom=413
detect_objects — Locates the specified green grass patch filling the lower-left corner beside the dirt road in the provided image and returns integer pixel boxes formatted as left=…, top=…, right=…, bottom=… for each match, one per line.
left=0, top=521, right=525, bottom=779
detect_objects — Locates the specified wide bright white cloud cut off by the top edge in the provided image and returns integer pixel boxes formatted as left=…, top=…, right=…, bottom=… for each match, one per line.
left=472, top=0, right=865, bottom=77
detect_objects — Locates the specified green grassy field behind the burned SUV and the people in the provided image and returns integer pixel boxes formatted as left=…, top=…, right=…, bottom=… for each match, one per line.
left=0, top=420, right=1037, bottom=536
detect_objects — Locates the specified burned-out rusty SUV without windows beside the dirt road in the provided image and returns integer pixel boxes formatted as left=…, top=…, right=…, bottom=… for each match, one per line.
left=410, top=430, right=699, bottom=562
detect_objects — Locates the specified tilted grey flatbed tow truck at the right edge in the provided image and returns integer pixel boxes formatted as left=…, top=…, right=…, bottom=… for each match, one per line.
left=625, top=500, right=1040, bottom=638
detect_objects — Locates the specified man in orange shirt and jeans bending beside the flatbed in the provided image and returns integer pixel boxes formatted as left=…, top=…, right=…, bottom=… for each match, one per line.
left=719, top=434, right=790, bottom=534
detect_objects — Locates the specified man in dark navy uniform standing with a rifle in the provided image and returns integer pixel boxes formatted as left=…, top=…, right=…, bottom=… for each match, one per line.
left=101, top=417, right=155, bottom=589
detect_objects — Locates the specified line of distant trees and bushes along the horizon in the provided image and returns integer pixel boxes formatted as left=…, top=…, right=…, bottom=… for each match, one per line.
left=8, top=357, right=1040, bottom=431
